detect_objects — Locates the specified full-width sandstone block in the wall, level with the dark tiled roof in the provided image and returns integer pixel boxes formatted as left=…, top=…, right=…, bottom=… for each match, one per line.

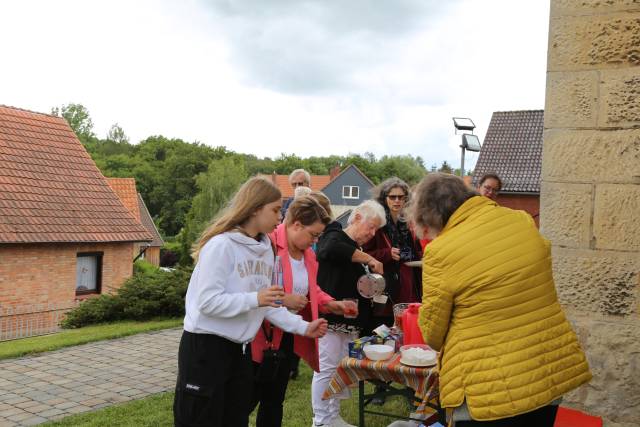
left=542, top=129, right=640, bottom=183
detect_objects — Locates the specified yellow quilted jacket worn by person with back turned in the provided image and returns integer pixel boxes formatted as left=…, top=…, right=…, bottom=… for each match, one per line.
left=419, top=196, right=591, bottom=421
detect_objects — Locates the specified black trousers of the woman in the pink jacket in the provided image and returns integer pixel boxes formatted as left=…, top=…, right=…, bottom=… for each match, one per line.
left=251, top=332, right=295, bottom=427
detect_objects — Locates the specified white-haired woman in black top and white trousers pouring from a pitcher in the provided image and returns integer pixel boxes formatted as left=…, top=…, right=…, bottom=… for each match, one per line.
left=311, top=200, right=386, bottom=426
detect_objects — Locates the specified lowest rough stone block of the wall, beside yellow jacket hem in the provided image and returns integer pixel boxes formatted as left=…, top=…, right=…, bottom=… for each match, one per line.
left=562, top=314, right=640, bottom=426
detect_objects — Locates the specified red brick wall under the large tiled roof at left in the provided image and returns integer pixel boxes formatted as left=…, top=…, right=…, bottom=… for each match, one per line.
left=0, top=243, right=133, bottom=336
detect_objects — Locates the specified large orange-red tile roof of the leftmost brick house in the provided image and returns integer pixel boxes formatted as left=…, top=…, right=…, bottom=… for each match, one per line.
left=0, top=105, right=152, bottom=244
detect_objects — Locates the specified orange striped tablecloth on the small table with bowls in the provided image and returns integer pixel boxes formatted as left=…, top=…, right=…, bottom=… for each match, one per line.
left=322, top=353, right=438, bottom=414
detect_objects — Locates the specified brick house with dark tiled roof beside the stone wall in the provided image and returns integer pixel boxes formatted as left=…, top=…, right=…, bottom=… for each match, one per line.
left=472, top=110, right=544, bottom=225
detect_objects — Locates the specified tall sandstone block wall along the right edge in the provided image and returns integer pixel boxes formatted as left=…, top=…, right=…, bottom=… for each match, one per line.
left=540, top=0, right=640, bottom=427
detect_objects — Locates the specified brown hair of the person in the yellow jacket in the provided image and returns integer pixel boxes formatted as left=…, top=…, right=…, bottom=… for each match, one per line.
left=409, top=173, right=478, bottom=232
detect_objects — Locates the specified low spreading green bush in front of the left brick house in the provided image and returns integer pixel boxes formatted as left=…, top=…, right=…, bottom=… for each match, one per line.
left=61, top=267, right=191, bottom=328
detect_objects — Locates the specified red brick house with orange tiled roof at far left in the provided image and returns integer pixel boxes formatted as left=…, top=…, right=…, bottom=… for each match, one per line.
left=0, top=106, right=153, bottom=338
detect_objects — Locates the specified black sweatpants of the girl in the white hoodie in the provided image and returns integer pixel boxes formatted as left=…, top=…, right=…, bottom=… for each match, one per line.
left=173, top=331, right=253, bottom=427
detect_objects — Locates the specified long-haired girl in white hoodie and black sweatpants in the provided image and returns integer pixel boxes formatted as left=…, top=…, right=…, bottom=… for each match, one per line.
left=173, top=178, right=327, bottom=427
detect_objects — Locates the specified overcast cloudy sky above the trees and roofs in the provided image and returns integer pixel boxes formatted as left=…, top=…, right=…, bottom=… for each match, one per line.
left=0, top=0, right=549, bottom=171
